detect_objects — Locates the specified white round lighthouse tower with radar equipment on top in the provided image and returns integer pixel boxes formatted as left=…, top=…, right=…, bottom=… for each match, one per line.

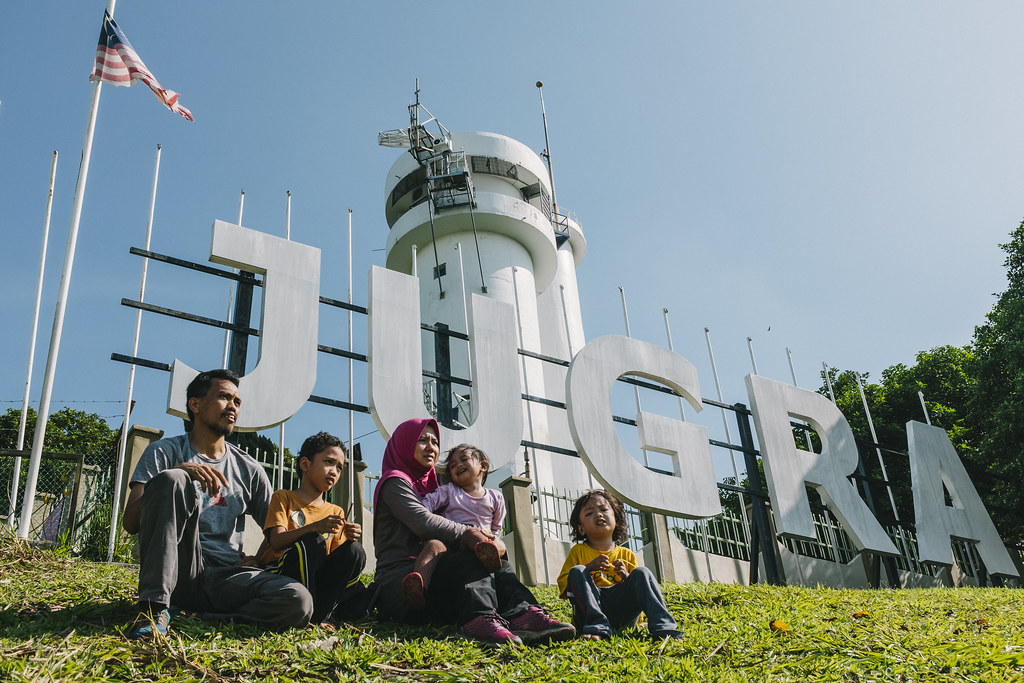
left=379, top=92, right=589, bottom=488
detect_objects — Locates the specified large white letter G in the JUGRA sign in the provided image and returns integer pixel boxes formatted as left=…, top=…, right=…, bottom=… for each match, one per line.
left=565, top=336, right=722, bottom=517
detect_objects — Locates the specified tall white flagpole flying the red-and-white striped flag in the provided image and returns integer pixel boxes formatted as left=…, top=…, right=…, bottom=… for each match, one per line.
left=17, top=0, right=116, bottom=539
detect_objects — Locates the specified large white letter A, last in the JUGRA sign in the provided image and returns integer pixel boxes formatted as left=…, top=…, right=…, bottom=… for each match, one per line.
left=906, top=421, right=1018, bottom=577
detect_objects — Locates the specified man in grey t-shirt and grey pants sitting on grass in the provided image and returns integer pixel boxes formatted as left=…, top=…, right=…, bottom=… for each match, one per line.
left=123, top=370, right=313, bottom=638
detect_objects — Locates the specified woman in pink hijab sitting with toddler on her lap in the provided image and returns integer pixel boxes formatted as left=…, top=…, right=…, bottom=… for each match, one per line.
left=374, top=418, right=575, bottom=644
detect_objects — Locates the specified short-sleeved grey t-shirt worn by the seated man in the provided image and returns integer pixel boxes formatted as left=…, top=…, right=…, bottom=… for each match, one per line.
left=131, top=434, right=272, bottom=566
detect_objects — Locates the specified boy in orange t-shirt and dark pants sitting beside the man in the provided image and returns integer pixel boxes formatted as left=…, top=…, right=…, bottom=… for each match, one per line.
left=260, top=432, right=367, bottom=624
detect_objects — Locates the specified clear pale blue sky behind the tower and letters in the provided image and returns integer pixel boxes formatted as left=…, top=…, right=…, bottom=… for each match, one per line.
left=0, top=0, right=1024, bottom=479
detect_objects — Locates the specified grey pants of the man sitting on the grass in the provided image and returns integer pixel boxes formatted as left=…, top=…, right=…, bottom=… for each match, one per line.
left=138, top=469, right=313, bottom=628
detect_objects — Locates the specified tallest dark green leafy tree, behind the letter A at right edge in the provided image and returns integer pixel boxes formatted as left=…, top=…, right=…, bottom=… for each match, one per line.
left=969, top=221, right=1024, bottom=544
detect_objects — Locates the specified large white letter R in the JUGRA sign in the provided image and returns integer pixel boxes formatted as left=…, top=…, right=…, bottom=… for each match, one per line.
left=745, top=375, right=899, bottom=555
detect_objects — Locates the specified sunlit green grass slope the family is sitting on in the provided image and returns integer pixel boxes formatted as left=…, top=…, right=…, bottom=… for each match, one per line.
left=0, top=540, right=1024, bottom=683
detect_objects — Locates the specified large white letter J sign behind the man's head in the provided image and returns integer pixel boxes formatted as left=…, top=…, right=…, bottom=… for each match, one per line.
left=167, top=220, right=321, bottom=431
